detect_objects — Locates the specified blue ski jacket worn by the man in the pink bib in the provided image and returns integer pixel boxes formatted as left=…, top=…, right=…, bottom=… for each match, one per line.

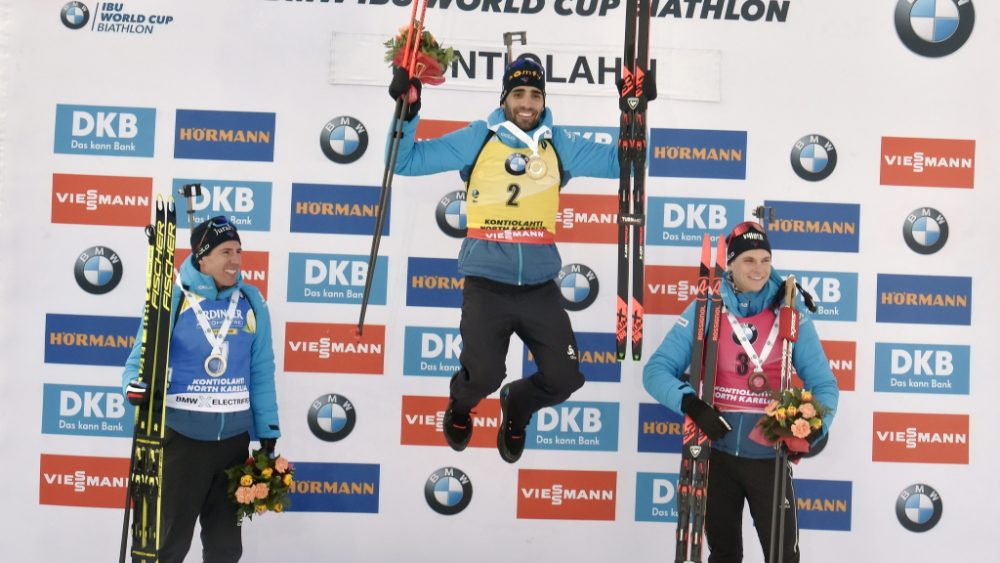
left=642, top=269, right=840, bottom=459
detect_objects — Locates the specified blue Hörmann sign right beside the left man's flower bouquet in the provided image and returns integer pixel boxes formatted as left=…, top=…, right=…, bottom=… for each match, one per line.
left=290, top=461, right=380, bottom=514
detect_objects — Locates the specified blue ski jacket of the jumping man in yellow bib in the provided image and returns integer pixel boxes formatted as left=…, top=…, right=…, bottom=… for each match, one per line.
left=386, top=108, right=619, bottom=285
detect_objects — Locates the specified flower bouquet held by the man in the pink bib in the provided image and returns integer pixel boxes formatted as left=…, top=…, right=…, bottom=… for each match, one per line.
left=750, top=387, right=829, bottom=453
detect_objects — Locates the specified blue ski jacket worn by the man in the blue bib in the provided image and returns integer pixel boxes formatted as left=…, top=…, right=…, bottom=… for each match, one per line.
left=122, top=258, right=281, bottom=441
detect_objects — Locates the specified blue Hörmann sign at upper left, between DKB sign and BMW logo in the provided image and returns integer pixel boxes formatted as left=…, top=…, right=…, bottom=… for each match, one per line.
left=174, top=109, right=275, bottom=162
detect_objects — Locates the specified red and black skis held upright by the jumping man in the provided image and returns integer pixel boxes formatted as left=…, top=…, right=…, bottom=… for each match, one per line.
left=615, top=0, right=650, bottom=361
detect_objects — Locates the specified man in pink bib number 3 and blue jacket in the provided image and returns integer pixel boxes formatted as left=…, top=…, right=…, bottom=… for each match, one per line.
left=642, top=221, right=839, bottom=563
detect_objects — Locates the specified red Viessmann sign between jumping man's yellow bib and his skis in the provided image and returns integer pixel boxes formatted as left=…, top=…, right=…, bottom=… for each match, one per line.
left=556, top=194, right=618, bottom=244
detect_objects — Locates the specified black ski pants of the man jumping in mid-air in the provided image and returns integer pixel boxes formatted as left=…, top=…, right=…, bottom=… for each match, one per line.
left=451, top=276, right=584, bottom=427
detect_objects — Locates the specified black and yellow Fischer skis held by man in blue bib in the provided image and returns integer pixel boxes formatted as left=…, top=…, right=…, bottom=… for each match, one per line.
left=118, top=196, right=177, bottom=563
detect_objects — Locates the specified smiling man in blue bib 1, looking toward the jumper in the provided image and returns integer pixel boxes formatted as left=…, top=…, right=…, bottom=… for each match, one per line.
left=122, top=216, right=281, bottom=563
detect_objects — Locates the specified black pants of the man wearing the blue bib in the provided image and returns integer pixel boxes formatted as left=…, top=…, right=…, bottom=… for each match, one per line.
left=160, top=428, right=250, bottom=563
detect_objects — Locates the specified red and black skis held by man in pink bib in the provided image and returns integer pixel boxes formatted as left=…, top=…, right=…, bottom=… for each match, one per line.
left=675, top=234, right=726, bottom=563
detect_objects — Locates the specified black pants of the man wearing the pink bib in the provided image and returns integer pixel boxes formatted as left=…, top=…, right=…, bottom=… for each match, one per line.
left=705, top=450, right=799, bottom=563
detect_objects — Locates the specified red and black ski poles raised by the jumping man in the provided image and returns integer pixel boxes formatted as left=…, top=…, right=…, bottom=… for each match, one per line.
left=358, top=0, right=427, bottom=337
